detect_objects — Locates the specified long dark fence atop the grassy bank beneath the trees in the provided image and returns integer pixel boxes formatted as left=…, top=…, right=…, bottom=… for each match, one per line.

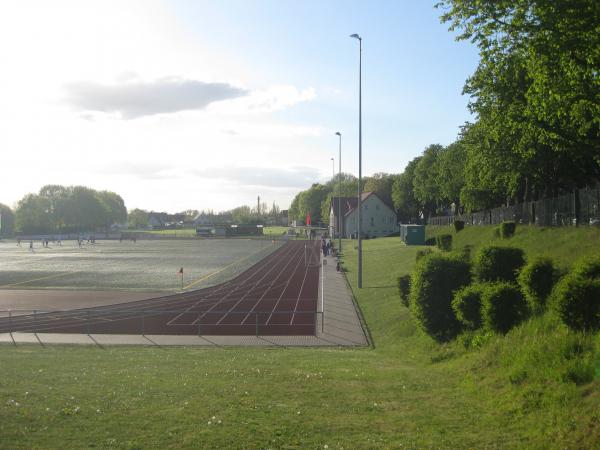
left=428, top=188, right=600, bottom=227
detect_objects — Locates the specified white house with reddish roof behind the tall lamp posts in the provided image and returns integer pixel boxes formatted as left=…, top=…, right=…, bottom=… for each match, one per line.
left=329, top=192, right=399, bottom=238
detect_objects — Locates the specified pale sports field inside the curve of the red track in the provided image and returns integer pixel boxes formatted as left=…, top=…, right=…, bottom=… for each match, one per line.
left=0, top=239, right=281, bottom=293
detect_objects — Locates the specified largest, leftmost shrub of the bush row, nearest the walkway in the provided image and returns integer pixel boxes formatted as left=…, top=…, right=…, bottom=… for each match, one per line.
left=410, top=254, right=471, bottom=342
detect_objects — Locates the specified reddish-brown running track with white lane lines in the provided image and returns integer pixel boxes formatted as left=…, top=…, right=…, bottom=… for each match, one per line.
left=0, top=241, right=320, bottom=336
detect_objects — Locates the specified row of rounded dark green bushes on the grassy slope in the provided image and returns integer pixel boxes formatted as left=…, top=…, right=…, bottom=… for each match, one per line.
left=398, top=246, right=600, bottom=341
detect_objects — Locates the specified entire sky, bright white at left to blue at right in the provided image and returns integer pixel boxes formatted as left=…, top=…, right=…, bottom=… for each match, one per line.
left=0, top=0, right=478, bottom=212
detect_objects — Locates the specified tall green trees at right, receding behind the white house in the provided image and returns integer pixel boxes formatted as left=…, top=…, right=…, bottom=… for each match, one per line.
left=290, top=0, right=600, bottom=223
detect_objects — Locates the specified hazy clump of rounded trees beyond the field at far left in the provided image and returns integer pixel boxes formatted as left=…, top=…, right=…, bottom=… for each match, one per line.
left=0, top=185, right=127, bottom=234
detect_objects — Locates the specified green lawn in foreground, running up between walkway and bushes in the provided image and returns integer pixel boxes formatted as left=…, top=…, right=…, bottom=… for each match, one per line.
left=0, top=230, right=600, bottom=448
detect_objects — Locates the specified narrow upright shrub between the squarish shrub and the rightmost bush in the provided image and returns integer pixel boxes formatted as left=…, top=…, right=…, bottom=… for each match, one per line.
left=518, top=258, right=557, bottom=312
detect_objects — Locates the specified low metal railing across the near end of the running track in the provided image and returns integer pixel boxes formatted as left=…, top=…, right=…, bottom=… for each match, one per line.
left=0, top=308, right=325, bottom=336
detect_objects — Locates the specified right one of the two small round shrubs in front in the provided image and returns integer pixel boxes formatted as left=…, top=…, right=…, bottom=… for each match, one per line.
left=481, top=282, right=528, bottom=333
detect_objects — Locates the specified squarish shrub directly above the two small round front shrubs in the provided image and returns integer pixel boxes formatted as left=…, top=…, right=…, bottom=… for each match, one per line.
left=474, top=246, right=525, bottom=282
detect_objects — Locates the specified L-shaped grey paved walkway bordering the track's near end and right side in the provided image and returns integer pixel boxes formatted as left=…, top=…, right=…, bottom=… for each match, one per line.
left=0, top=256, right=368, bottom=347
